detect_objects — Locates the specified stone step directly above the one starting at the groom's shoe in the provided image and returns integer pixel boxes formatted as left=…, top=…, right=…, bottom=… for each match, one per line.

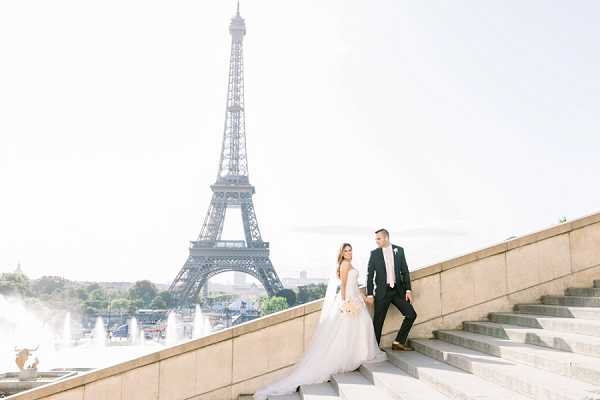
left=434, top=330, right=600, bottom=384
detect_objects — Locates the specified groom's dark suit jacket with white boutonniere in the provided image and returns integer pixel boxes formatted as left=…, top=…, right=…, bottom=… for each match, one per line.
left=367, top=244, right=411, bottom=298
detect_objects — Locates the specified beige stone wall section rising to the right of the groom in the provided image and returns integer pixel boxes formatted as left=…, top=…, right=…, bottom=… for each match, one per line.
left=382, top=213, right=600, bottom=345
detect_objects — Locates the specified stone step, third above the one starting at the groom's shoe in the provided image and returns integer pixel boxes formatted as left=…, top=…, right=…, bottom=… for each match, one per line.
left=489, top=312, right=600, bottom=336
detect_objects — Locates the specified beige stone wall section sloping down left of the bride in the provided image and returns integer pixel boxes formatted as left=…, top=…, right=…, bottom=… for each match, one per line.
left=10, top=300, right=322, bottom=400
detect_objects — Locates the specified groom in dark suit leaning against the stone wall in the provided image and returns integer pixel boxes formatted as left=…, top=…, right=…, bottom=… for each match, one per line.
left=367, top=229, right=417, bottom=350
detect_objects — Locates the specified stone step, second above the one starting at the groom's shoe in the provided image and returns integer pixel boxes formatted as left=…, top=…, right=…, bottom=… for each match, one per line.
left=463, top=321, right=600, bottom=357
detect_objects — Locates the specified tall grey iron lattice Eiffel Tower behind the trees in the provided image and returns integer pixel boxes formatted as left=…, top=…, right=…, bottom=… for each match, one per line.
left=169, top=2, right=283, bottom=307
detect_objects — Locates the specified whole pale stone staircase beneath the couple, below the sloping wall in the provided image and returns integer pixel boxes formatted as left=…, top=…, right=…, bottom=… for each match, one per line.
left=260, top=280, right=600, bottom=400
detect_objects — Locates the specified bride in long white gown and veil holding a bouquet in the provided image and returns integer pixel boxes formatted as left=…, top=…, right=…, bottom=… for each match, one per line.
left=254, top=243, right=386, bottom=400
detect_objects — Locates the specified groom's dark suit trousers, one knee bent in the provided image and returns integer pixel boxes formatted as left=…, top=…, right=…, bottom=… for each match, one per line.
left=373, top=285, right=417, bottom=344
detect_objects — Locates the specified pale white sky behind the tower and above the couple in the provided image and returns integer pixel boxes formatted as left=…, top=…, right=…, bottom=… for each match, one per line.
left=0, top=0, right=600, bottom=283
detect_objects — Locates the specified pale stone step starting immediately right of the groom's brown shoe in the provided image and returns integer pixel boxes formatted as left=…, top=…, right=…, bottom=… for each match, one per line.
left=410, top=339, right=600, bottom=400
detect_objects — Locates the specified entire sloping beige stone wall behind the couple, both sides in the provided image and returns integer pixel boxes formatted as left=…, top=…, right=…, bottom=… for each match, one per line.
left=12, top=213, right=600, bottom=400
